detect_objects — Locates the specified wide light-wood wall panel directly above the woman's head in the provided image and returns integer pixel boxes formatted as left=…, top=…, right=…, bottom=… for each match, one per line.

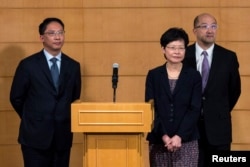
left=83, top=8, right=201, bottom=42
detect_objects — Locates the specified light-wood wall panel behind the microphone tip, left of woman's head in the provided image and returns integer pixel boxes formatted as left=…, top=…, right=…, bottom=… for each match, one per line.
left=82, top=42, right=162, bottom=76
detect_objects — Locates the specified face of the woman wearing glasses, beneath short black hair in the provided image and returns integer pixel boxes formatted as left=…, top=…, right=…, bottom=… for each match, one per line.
left=162, top=40, right=186, bottom=63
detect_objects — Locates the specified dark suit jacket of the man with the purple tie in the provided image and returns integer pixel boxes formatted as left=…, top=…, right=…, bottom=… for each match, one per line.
left=184, top=44, right=241, bottom=145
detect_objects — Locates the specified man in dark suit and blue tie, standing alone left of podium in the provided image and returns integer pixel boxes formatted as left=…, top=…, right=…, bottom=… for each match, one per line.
left=10, top=18, right=81, bottom=167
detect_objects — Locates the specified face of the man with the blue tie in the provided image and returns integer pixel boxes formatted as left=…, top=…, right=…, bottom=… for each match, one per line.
left=40, top=22, right=64, bottom=55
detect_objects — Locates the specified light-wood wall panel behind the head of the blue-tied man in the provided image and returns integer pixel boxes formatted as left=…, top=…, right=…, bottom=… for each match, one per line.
left=0, top=9, right=83, bottom=43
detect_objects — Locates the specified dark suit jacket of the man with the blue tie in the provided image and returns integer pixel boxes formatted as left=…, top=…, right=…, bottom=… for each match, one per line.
left=10, top=51, right=81, bottom=149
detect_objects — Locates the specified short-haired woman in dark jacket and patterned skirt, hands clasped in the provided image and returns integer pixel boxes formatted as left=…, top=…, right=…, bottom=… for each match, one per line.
left=145, top=28, right=202, bottom=167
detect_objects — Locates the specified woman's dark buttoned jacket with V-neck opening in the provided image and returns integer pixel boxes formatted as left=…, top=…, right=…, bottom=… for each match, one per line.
left=145, top=64, right=201, bottom=144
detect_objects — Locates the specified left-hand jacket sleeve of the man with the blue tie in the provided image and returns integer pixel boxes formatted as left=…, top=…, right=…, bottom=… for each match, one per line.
left=10, top=61, right=29, bottom=118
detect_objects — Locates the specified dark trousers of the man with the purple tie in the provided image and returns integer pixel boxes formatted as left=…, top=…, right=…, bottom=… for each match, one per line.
left=198, top=120, right=231, bottom=167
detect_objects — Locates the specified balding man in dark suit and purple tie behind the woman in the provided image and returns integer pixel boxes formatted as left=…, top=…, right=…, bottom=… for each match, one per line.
left=183, top=13, right=241, bottom=166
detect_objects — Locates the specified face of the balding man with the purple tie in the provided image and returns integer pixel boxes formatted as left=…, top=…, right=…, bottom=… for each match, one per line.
left=193, top=15, right=217, bottom=46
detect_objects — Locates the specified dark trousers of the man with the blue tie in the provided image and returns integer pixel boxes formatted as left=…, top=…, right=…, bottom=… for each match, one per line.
left=21, top=145, right=70, bottom=167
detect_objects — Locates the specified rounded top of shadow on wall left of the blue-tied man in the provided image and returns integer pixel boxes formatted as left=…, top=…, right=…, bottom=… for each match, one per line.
left=0, top=45, right=25, bottom=77
